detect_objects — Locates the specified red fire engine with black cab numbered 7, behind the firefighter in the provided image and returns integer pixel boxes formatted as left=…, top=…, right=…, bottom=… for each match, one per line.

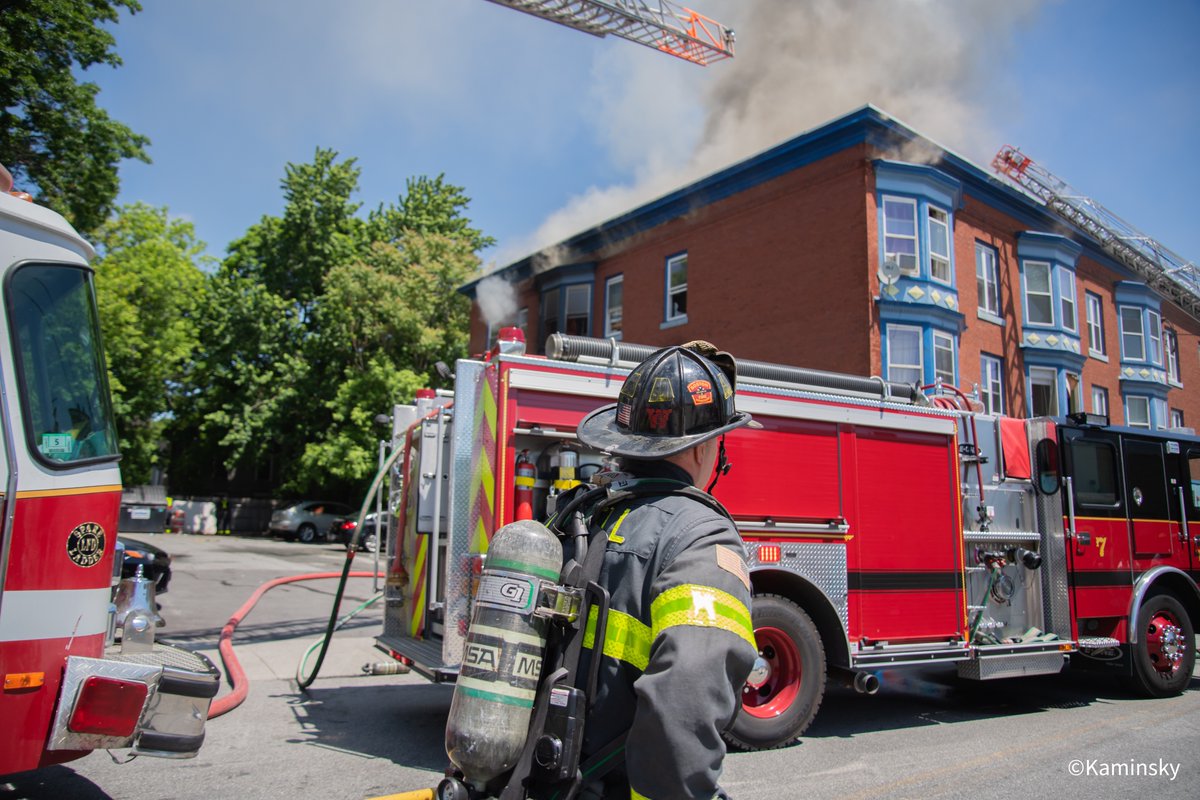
left=377, top=329, right=1200, bottom=748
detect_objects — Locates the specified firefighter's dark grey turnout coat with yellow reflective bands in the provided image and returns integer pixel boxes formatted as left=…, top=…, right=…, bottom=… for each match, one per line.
left=581, top=462, right=757, bottom=800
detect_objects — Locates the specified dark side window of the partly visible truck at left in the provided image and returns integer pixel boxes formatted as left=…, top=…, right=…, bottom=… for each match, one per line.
left=7, top=264, right=118, bottom=467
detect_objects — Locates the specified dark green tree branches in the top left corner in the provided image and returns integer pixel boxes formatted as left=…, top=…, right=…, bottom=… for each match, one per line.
left=0, top=0, right=150, bottom=233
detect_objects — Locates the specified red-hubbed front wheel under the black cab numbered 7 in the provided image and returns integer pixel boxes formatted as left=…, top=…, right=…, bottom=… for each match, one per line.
left=1133, top=595, right=1196, bottom=697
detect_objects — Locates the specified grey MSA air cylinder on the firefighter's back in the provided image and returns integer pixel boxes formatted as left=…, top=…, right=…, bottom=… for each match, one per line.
left=446, top=519, right=563, bottom=789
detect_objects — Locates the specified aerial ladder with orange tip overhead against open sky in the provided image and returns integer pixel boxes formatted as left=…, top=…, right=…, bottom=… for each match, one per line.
left=480, top=0, right=733, bottom=66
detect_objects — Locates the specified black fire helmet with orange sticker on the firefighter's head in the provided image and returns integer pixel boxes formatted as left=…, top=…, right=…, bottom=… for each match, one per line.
left=578, top=342, right=760, bottom=459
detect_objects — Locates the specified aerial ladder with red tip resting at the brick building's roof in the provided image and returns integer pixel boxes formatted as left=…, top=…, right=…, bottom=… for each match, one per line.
left=991, top=144, right=1200, bottom=320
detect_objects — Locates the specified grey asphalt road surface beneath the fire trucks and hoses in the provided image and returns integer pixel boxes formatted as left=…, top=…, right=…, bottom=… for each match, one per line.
left=0, top=535, right=1200, bottom=800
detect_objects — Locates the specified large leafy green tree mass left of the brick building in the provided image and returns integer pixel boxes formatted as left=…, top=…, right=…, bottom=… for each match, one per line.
left=164, top=149, right=491, bottom=499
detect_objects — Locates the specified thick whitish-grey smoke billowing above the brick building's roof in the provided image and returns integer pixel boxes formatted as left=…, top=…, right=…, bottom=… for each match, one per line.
left=499, top=0, right=1046, bottom=264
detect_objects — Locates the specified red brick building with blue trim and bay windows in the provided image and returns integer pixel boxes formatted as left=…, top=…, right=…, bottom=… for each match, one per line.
left=463, top=106, right=1200, bottom=427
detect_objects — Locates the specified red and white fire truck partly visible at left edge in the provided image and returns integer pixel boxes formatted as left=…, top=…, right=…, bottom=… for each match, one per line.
left=0, top=168, right=220, bottom=775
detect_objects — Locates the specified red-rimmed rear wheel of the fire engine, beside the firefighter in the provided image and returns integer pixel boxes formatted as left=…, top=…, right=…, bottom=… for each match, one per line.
left=725, top=595, right=826, bottom=750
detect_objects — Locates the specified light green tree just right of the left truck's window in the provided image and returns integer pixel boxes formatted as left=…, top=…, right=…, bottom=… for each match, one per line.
left=95, top=203, right=206, bottom=483
